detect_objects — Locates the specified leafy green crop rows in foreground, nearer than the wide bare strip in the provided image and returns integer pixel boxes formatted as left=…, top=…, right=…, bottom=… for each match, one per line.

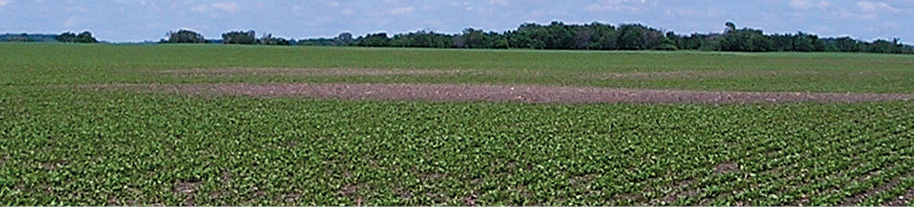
left=0, top=87, right=914, bottom=205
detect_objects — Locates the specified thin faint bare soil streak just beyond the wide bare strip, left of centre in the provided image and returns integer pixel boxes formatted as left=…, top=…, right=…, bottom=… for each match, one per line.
left=156, top=68, right=471, bottom=77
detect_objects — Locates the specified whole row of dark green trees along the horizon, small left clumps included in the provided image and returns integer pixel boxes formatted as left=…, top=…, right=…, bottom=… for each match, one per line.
left=7, top=21, right=914, bottom=54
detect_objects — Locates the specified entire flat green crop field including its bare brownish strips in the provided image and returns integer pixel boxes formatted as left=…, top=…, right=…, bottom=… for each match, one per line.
left=0, top=44, right=914, bottom=206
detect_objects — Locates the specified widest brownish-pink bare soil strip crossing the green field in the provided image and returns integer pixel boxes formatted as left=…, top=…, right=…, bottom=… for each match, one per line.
left=78, top=83, right=914, bottom=103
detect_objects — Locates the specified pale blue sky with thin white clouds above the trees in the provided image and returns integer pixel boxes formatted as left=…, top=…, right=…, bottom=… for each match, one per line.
left=0, top=0, right=914, bottom=44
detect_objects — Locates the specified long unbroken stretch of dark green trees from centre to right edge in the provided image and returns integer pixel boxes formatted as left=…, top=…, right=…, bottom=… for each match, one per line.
left=336, top=21, right=914, bottom=54
